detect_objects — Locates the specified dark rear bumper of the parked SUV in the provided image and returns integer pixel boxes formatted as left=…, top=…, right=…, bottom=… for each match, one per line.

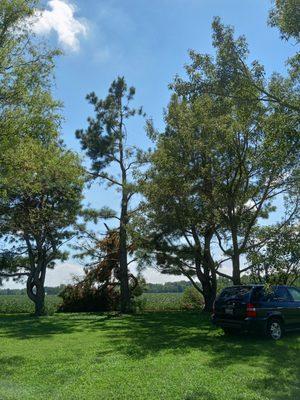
left=211, top=315, right=267, bottom=332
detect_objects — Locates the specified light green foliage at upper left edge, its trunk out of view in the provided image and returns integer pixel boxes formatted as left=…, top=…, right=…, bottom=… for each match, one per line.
left=0, top=0, right=61, bottom=236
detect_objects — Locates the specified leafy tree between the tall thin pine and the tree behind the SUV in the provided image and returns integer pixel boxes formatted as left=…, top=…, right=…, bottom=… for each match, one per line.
left=137, top=94, right=218, bottom=311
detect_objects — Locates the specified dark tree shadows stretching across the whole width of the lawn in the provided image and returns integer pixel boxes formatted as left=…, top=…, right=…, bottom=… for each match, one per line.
left=0, top=312, right=300, bottom=400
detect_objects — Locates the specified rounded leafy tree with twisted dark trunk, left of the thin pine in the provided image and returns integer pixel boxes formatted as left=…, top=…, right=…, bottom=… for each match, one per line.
left=0, top=139, right=83, bottom=315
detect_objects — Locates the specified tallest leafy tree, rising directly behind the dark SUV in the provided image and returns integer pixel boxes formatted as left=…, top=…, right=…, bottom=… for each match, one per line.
left=172, top=19, right=299, bottom=284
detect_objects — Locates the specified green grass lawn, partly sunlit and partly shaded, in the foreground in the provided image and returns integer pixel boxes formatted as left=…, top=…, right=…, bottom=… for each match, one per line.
left=0, top=312, right=300, bottom=400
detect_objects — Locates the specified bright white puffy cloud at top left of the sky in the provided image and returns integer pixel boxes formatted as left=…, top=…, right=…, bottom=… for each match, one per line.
left=33, top=0, right=88, bottom=51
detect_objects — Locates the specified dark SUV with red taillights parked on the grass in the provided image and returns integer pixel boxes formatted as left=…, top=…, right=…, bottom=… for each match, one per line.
left=212, top=285, right=300, bottom=340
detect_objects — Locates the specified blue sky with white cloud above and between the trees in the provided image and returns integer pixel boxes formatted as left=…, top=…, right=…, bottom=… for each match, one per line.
left=4, top=0, right=295, bottom=284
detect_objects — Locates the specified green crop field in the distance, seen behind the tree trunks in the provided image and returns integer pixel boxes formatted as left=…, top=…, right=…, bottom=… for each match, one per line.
left=0, top=293, right=182, bottom=314
